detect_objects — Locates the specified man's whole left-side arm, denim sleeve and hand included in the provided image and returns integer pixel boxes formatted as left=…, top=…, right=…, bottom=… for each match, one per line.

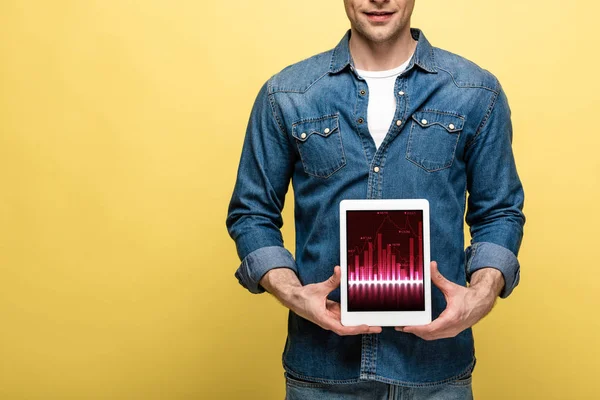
left=226, top=83, right=381, bottom=335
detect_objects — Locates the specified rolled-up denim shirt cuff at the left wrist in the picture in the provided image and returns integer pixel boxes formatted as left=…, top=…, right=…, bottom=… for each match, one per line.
left=235, top=246, right=298, bottom=293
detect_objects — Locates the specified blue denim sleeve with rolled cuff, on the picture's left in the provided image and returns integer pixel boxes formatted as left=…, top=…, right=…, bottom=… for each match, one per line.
left=226, top=82, right=297, bottom=293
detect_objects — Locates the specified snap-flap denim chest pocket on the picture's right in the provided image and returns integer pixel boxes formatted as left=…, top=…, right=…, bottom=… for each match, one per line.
left=406, top=110, right=465, bottom=172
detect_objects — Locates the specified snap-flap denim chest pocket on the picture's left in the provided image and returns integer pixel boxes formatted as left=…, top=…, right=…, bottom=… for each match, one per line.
left=292, top=115, right=346, bottom=178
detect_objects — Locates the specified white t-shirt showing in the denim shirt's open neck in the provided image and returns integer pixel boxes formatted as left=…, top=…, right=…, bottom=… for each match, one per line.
left=356, top=55, right=412, bottom=148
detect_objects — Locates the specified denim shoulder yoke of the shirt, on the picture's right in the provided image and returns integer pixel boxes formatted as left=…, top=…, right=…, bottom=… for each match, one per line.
left=433, top=47, right=500, bottom=93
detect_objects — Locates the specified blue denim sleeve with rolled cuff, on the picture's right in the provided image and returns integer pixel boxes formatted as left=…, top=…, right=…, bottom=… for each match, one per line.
left=465, top=83, right=525, bottom=298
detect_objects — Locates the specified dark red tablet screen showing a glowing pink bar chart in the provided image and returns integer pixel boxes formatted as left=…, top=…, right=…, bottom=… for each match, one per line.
left=346, top=210, right=425, bottom=311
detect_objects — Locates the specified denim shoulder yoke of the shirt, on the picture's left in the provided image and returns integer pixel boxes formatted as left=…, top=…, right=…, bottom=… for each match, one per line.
left=268, top=49, right=333, bottom=94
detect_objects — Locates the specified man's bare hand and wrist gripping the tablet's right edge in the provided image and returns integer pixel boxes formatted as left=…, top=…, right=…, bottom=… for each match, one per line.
left=396, top=261, right=504, bottom=340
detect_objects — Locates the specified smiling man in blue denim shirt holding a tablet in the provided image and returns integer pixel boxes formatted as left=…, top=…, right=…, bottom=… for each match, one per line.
left=226, top=0, right=525, bottom=399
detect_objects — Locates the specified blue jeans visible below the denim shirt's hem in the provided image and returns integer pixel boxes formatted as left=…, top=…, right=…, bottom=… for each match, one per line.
left=285, top=373, right=473, bottom=400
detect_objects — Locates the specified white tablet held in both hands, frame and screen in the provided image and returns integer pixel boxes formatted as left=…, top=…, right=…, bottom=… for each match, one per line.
left=340, top=199, right=431, bottom=326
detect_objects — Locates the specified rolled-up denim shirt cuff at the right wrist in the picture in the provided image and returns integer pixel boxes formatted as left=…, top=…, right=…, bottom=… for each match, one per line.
left=465, top=242, right=520, bottom=299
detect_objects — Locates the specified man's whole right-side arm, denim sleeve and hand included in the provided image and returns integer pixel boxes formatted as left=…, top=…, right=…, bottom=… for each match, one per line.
left=397, top=86, right=525, bottom=340
